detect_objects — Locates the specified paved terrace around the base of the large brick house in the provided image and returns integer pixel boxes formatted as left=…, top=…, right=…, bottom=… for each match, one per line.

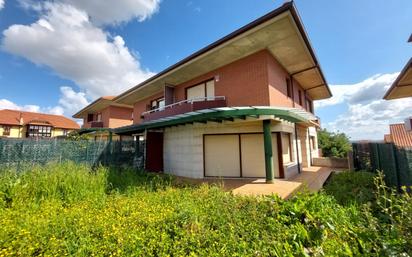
left=174, top=167, right=332, bottom=199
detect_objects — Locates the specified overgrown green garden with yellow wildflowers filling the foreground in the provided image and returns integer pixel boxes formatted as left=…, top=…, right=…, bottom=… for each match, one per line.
left=0, top=163, right=412, bottom=256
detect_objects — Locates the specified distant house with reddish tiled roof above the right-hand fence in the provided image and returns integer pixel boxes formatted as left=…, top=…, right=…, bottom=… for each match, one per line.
left=384, top=118, right=412, bottom=147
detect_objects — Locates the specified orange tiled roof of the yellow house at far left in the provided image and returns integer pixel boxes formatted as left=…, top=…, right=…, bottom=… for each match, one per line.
left=0, top=109, right=80, bottom=129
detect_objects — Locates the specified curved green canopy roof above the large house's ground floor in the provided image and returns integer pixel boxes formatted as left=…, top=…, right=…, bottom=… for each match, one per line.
left=113, top=106, right=317, bottom=134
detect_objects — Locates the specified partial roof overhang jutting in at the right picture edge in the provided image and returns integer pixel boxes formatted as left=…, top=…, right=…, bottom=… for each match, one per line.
left=383, top=58, right=412, bottom=100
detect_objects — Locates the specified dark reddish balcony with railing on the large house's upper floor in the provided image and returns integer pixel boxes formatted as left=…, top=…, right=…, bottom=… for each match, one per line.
left=142, top=96, right=226, bottom=122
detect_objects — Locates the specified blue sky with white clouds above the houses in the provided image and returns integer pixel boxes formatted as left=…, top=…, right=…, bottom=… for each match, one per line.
left=0, top=0, right=412, bottom=140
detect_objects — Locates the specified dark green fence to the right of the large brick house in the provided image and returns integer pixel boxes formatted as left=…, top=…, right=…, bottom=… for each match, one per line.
left=352, top=143, right=412, bottom=187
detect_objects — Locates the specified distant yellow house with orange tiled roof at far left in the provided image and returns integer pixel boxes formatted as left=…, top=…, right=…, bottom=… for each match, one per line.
left=0, top=110, right=79, bottom=138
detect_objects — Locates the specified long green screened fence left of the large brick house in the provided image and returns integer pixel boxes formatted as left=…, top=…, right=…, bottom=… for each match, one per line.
left=0, top=139, right=145, bottom=169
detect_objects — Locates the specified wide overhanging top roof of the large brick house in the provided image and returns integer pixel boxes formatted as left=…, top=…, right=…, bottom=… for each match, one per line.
left=114, top=2, right=332, bottom=104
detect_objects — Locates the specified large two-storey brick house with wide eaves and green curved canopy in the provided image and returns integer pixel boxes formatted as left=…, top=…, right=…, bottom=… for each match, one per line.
left=91, top=2, right=331, bottom=183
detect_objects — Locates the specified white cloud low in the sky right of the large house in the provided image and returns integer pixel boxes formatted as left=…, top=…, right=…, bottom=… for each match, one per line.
left=318, top=73, right=412, bottom=140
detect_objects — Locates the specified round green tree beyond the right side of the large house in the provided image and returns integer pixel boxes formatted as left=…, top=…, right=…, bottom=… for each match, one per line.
left=318, top=129, right=351, bottom=158
